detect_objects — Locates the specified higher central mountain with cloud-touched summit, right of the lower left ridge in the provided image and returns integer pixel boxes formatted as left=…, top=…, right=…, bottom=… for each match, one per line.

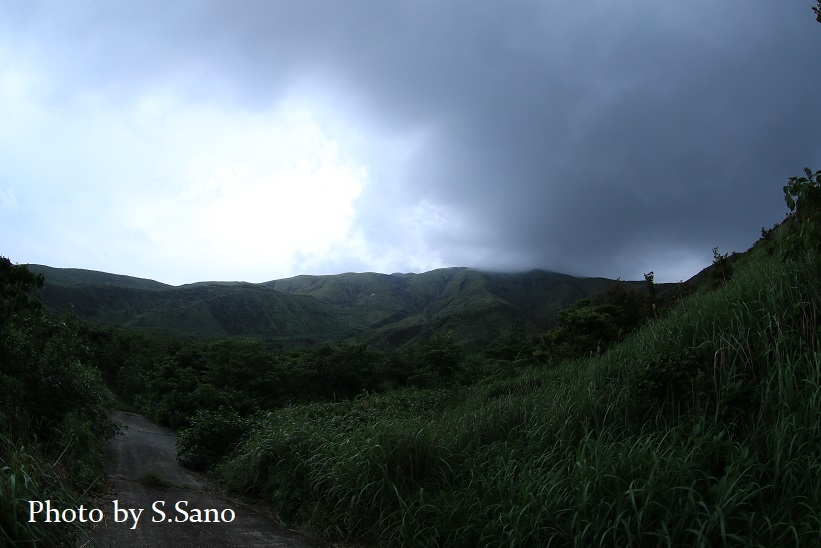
left=270, top=268, right=660, bottom=347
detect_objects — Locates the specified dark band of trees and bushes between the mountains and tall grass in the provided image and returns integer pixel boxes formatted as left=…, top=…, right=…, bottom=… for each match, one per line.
left=85, top=326, right=516, bottom=468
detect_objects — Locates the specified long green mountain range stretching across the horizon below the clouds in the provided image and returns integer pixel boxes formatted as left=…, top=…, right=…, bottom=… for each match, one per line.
left=29, top=265, right=668, bottom=346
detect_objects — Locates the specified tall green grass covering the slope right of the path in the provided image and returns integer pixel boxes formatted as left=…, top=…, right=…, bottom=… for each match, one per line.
left=215, top=254, right=821, bottom=546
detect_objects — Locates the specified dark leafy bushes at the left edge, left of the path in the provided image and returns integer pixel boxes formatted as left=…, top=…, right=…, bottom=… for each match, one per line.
left=0, top=257, right=115, bottom=546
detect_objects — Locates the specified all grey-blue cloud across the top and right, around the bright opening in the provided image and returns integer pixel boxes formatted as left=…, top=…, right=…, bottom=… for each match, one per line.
left=10, top=0, right=821, bottom=281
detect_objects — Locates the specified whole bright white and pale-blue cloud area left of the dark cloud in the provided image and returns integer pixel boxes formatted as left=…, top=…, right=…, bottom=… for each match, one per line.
left=0, top=42, right=455, bottom=284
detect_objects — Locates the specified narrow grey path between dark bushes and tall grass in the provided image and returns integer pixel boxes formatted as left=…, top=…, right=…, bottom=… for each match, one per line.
left=78, top=411, right=317, bottom=548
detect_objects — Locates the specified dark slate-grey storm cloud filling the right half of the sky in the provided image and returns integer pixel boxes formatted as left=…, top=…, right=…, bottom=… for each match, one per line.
left=346, top=1, right=821, bottom=279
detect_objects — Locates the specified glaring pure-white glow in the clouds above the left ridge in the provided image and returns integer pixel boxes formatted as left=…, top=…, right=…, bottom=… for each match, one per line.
left=92, top=96, right=368, bottom=281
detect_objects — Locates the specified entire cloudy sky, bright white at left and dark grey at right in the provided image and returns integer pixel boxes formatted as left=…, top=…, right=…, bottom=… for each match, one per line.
left=0, top=0, right=821, bottom=285
